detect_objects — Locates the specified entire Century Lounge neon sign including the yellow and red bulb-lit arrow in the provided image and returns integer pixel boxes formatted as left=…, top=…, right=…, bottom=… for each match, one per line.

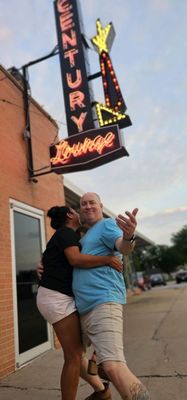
left=50, top=0, right=130, bottom=174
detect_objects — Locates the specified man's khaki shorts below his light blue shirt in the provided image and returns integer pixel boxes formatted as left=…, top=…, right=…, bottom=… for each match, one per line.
left=80, top=303, right=126, bottom=364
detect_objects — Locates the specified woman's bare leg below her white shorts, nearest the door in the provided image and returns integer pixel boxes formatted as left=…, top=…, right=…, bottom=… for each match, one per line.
left=53, top=312, right=83, bottom=400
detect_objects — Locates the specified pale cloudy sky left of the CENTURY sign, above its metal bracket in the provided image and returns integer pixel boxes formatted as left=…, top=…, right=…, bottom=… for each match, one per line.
left=0, top=0, right=57, bottom=68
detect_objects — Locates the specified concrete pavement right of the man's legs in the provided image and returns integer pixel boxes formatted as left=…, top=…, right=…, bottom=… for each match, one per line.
left=121, top=283, right=187, bottom=400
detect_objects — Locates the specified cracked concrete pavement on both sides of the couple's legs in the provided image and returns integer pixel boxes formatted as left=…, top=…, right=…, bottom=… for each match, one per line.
left=0, top=284, right=187, bottom=400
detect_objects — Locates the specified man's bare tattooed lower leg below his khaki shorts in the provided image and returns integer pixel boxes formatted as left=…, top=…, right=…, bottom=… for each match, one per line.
left=102, top=361, right=150, bottom=400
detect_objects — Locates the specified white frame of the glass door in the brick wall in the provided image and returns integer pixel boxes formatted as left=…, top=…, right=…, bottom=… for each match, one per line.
left=9, top=199, right=54, bottom=368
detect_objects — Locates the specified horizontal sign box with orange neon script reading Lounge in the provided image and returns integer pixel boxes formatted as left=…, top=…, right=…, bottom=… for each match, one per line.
left=50, top=125, right=128, bottom=174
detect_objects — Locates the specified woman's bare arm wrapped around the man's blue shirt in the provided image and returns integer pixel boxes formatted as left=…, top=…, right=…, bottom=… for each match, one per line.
left=64, top=246, right=123, bottom=272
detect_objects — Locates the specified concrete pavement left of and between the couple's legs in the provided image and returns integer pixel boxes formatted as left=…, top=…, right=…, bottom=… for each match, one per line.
left=0, top=350, right=120, bottom=400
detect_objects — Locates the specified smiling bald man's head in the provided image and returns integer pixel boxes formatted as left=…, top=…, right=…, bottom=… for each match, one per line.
left=80, top=192, right=103, bottom=226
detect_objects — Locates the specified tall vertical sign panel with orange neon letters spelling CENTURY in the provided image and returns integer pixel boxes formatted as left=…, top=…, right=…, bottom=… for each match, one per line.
left=54, top=0, right=94, bottom=136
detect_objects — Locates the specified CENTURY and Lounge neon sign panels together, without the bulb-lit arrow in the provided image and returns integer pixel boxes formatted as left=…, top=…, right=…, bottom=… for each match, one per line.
left=50, top=0, right=128, bottom=174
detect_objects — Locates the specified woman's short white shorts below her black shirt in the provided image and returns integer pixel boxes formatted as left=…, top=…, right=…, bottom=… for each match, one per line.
left=36, top=286, right=77, bottom=325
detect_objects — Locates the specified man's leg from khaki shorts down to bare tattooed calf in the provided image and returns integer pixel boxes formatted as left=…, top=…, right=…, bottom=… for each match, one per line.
left=81, top=303, right=150, bottom=400
